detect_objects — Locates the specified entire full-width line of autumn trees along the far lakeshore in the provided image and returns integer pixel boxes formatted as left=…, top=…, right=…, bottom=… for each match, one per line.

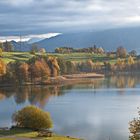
left=0, top=53, right=140, bottom=84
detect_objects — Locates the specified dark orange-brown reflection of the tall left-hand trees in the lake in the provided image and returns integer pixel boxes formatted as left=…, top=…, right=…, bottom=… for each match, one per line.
left=0, top=86, right=71, bottom=108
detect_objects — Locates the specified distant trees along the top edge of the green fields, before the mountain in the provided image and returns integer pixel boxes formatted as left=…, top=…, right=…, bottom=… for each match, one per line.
left=0, top=41, right=137, bottom=58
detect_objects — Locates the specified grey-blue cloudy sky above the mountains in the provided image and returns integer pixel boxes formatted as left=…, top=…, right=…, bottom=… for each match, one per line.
left=0, top=0, right=140, bottom=36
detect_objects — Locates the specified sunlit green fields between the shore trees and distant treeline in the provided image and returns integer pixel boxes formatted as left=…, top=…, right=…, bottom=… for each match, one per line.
left=2, top=52, right=117, bottom=64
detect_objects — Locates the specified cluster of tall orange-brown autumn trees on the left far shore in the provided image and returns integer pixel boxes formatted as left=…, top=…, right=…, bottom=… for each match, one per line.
left=0, top=56, right=60, bottom=84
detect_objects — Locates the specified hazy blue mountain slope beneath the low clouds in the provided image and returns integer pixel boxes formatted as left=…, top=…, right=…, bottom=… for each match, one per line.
left=11, top=27, right=140, bottom=52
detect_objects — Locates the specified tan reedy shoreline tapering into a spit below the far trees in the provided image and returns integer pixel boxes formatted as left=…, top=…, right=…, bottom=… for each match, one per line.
left=0, top=73, right=105, bottom=88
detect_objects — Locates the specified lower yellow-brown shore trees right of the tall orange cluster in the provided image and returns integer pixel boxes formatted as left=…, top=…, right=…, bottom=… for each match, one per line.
left=58, top=56, right=140, bottom=74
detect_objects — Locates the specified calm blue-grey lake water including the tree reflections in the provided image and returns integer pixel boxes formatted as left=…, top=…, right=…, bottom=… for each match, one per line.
left=0, top=75, right=140, bottom=140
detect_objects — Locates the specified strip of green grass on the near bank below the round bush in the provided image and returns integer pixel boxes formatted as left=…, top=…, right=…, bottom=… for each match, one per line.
left=0, top=129, right=79, bottom=140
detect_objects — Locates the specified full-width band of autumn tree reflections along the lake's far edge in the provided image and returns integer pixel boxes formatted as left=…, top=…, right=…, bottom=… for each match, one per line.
left=0, top=75, right=140, bottom=108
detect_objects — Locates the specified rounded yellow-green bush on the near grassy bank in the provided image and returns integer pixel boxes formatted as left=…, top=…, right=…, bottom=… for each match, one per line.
left=13, top=106, right=52, bottom=130
